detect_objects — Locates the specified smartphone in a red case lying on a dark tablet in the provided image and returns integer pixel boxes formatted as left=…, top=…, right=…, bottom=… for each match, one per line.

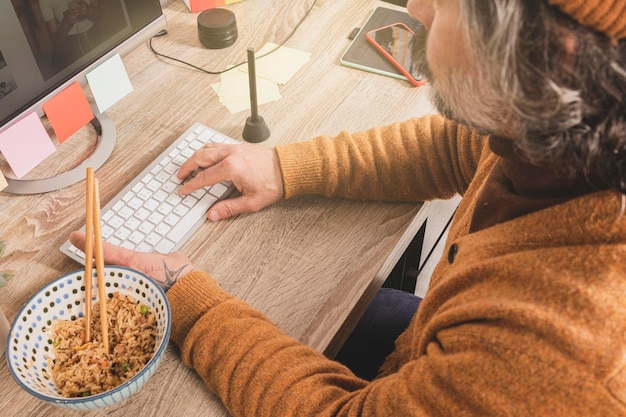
left=365, top=23, right=428, bottom=87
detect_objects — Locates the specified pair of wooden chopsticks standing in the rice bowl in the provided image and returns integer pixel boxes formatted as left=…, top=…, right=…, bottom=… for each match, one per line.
left=85, top=168, right=109, bottom=352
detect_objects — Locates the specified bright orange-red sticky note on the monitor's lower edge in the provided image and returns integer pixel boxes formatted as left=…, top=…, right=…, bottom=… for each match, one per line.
left=42, top=82, right=93, bottom=143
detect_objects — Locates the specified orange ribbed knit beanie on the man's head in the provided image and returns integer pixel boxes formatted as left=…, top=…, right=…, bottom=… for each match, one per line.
left=548, top=0, right=626, bottom=40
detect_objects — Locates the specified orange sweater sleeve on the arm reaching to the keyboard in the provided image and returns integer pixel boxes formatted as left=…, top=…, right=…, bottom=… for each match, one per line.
left=276, top=115, right=484, bottom=201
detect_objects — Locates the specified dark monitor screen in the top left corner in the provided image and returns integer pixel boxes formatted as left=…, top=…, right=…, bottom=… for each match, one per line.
left=0, top=0, right=164, bottom=127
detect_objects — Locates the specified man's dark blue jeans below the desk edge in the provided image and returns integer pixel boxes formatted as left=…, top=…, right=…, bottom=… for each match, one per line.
left=335, top=288, right=422, bottom=380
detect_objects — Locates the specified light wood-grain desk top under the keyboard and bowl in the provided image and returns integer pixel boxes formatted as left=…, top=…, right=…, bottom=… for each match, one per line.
left=0, top=0, right=432, bottom=417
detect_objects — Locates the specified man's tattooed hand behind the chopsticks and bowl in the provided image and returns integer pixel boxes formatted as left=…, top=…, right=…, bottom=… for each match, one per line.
left=70, top=232, right=195, bottom=291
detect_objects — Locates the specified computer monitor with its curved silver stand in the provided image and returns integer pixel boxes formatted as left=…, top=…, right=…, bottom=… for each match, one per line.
left=0, top=0, right=166, bottom=194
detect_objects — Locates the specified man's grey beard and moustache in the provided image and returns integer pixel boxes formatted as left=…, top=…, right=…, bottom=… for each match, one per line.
left=411, top=25, right=520, bottom=138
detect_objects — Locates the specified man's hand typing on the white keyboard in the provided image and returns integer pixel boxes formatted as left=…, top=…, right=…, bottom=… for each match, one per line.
left=177, top=144, right=284, bottom=221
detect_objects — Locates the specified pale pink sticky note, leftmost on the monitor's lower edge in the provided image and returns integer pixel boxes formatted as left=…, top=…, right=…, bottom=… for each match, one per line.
left=0, top=113, right=56, bottom=178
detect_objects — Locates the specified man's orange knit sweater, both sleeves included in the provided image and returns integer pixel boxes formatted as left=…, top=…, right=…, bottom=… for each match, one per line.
left=168, top=116, right=626, bottom=417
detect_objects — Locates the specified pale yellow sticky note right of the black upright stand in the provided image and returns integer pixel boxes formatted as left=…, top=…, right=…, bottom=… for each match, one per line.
left=240, top=43, right=311, bottom=84
